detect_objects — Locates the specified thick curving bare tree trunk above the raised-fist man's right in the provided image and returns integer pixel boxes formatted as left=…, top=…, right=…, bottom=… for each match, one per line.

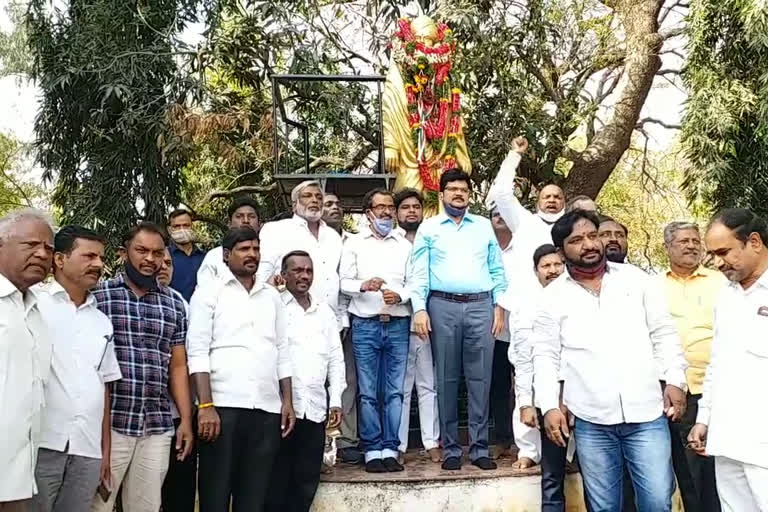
left=565, top=0, right=664, bottom=198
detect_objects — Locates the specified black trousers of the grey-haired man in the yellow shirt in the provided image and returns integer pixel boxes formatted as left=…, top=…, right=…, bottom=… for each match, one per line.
left=669, top=393, right=720, bottom=512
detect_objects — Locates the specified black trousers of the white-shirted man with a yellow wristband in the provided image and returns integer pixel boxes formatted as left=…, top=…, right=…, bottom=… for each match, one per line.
left=198, top=407, right=280, bottom=512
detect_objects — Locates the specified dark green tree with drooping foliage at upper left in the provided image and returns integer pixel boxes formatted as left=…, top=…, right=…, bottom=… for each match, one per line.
left=27, top=0, right=200, bottom=253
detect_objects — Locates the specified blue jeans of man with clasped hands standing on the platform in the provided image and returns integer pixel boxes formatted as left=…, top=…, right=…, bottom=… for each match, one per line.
left=352, top=316, right=411, bottom=462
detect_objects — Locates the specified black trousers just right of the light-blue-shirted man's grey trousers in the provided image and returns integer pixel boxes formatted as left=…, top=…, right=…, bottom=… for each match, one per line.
left=490, top=340, right=515, bottom=447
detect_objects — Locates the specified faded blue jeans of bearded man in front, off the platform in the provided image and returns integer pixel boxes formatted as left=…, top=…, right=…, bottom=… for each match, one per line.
left=574, top=416, right=675, bottom=512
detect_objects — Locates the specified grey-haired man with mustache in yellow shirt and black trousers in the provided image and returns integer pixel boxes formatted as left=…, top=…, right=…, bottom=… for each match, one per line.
left=661, top=222, right=726, bottom=512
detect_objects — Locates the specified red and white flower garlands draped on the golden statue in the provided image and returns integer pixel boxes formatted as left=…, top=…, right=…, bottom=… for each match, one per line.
left=392, top=18, right=461, bottom=191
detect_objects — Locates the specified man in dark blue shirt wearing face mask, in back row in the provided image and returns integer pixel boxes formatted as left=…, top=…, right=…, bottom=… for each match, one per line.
left=168, top=209, right=205, bottom=302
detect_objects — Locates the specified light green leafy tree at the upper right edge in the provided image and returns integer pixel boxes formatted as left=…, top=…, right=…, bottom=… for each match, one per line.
left=682, top=0, right=768, bottom=216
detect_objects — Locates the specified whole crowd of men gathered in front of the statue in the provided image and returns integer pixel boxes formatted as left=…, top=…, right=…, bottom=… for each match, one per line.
left=0, top=139, right=768, bottom=512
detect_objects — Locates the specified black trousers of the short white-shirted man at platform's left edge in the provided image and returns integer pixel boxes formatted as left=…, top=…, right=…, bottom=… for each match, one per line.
left=265, top=420, right=325, bottom=512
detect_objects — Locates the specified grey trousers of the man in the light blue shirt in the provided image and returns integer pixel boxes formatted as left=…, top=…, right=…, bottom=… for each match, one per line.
left=427, top=296, right=494, bottom=461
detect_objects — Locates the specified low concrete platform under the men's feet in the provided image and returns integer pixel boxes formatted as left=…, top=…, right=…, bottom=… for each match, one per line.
left=312, top=453, right=586, bottom=512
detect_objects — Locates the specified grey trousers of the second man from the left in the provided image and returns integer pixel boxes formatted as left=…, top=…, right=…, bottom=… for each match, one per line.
left=32, top=448, right=101, bottom=512
